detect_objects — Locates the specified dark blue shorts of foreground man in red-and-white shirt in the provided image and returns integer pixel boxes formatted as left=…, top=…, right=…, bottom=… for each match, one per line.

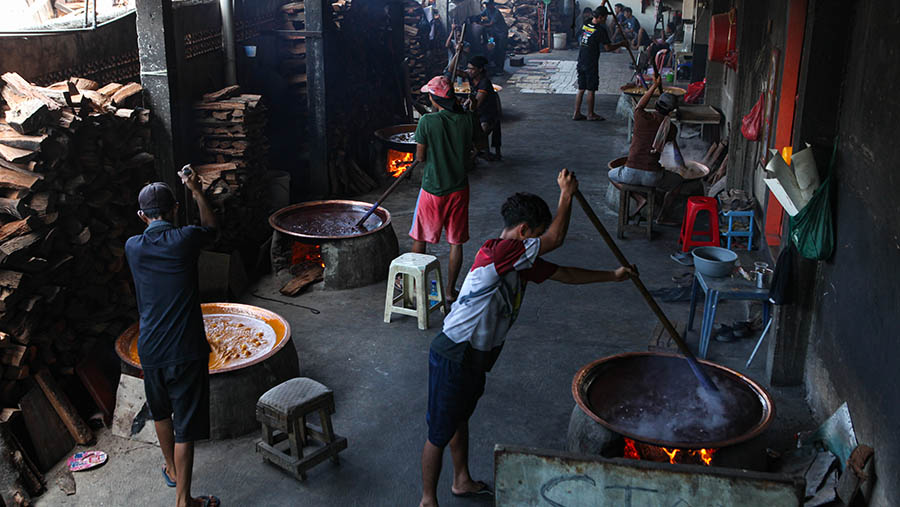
left=425, top=350, right=485, bottom=447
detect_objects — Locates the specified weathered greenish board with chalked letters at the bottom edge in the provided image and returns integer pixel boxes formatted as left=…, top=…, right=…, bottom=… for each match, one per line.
left=494, top=445, right=803, bottom=507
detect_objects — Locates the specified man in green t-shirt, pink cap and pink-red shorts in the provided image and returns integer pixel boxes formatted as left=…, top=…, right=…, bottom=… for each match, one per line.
left=409, top=76, right=475, bottom=302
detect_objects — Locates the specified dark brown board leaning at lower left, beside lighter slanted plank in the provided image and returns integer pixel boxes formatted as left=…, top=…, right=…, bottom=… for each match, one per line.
left=19, top=386, right=75, bottom=472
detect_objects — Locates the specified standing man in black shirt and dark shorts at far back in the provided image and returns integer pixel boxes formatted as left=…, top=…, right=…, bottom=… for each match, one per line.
left=572, top=7, right=627, bottom=121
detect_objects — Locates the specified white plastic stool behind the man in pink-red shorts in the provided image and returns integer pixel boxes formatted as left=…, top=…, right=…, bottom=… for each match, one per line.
left=384, top=253, right=447, bottom=330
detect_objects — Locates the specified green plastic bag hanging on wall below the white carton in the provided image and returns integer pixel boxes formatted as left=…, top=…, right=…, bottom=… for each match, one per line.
left=791, top=176, right=834, bottom=261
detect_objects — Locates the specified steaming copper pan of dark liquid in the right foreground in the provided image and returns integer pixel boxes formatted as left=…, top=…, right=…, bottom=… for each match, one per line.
left=572, top=352, right=775, bottom=449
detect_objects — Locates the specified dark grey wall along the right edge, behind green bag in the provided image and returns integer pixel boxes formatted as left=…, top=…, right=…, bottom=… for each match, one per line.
left=806, top=0, right=900, bottom=505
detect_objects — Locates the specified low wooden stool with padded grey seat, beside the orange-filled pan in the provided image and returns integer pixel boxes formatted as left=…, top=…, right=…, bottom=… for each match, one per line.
left=256, top=377, right=347, bottom=481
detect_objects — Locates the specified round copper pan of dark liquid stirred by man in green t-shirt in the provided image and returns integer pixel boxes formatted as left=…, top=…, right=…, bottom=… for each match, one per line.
left=269, top=200, right=391, bottom=244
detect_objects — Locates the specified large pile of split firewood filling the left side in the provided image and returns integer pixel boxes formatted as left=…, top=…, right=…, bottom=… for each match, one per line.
left=0, top=73, right=153, bottom=500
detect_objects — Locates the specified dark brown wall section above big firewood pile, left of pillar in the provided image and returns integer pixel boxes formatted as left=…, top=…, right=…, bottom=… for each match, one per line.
left=0, top=13, right=140, bottom=85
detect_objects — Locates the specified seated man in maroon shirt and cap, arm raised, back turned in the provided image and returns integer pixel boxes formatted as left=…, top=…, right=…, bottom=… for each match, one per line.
left=609, top=76, right=684, bottom=220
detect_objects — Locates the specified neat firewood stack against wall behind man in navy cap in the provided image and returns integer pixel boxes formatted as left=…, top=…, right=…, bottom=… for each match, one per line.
left=194, top=85, right=268, bottom=252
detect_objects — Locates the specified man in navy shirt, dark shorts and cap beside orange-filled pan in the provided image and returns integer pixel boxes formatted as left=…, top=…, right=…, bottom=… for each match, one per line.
left=125, top=166, right=219, bottom=507
